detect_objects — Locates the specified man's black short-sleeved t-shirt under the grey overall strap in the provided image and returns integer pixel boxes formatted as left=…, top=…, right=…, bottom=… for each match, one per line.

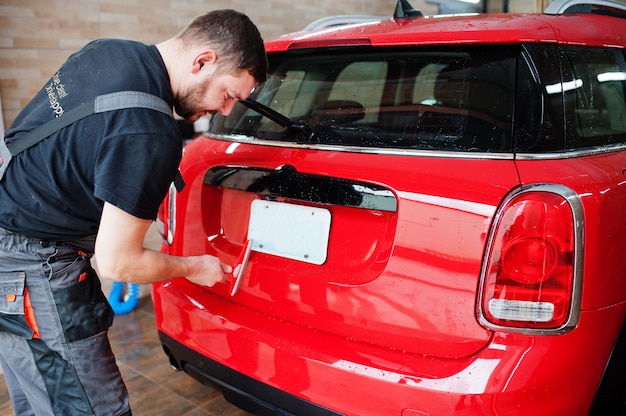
left=0, top=39, right=182, bottom=241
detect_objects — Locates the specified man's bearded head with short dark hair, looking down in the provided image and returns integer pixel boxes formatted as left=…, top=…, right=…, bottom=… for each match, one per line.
left=157, top=10, right=267, bottom=121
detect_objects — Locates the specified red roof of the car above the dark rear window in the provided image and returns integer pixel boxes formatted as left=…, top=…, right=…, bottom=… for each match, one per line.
left=266, top=13, right=626, bottom=52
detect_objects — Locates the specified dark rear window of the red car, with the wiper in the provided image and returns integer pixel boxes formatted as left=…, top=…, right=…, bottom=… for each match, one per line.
left=211, top=45, right=517, bottom=152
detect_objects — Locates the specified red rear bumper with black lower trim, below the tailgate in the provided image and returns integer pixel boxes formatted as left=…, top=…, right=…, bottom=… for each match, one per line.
left=153, top=283, right=624, bottom=416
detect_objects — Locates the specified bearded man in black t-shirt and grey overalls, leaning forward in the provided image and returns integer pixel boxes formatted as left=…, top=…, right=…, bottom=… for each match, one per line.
left=0, top=10, right=267, bottom=416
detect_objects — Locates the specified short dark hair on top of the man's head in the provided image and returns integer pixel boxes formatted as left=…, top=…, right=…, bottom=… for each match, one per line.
left=179, top=9, right=267, bottom=83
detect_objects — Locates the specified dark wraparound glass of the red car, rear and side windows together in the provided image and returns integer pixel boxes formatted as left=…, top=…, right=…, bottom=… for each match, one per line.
left=211, top=44, right=626, bottom=153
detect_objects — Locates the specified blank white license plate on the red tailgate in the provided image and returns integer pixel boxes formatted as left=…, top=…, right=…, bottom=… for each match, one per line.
left=248, top=199, right=331, bottom=264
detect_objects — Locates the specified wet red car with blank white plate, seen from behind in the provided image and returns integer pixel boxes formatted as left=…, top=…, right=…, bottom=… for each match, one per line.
left=152, top=0, right=626, bottom=416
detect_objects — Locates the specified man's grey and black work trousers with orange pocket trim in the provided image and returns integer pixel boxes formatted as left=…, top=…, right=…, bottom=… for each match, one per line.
left=0, top=229, right=130, bottom=416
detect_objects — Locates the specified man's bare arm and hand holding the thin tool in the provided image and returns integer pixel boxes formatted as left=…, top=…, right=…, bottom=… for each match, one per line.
left=96, top=203, right=232, bottom=286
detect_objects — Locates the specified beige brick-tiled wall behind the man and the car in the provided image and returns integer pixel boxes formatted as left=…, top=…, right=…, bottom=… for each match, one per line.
left=0, top=0, right=626, bottom=127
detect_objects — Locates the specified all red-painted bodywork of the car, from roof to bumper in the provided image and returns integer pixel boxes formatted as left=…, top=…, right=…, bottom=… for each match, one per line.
left=152, top=4, right=626, bottom=416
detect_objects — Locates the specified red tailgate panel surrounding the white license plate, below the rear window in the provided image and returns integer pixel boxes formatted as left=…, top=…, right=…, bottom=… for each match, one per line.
left=157, top=138, right=518, bottom=357
